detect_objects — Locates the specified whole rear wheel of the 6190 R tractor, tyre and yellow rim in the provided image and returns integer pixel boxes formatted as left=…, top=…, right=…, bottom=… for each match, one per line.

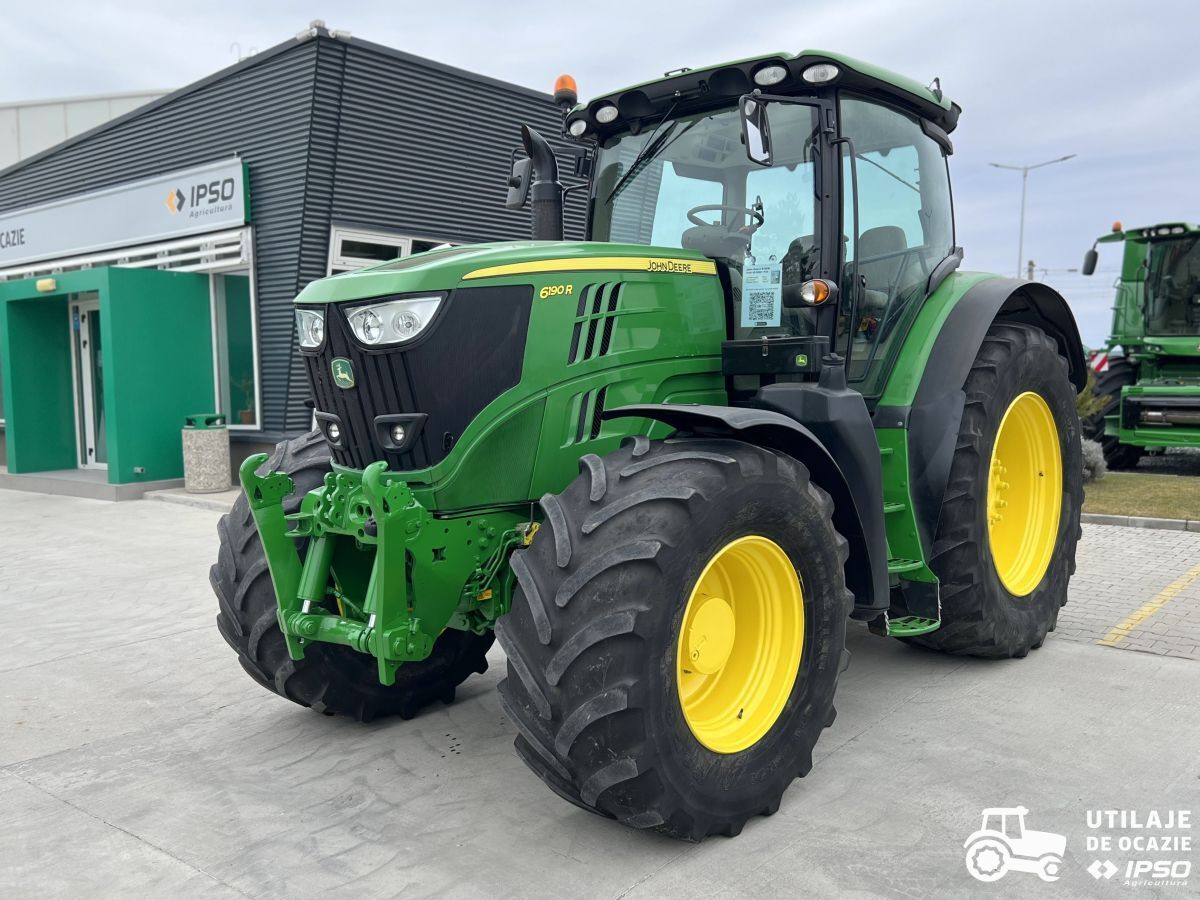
left=907, top=323, right=1084, bottom=658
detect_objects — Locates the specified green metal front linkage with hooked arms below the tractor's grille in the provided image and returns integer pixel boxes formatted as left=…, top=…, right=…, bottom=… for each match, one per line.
left=239, top=454, right=536, bottom=685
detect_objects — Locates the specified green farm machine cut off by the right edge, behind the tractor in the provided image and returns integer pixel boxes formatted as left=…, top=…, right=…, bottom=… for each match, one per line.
left=1082, top=222, right=1200, bottom=469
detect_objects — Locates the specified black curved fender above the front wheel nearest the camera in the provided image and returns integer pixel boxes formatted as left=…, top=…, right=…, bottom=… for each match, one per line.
left=604, top=403, right=889, bottom=618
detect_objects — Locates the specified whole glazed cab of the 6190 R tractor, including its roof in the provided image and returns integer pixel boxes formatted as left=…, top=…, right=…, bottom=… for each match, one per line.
left=556, top=53, right=959, bottom=396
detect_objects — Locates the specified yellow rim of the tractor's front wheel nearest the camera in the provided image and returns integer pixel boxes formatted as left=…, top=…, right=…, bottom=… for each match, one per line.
left=676, top=535, right=804, bottom=754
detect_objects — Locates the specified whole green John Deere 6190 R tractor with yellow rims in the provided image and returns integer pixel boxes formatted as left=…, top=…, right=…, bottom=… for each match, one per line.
left=211, top=52, right=1086, bottom=840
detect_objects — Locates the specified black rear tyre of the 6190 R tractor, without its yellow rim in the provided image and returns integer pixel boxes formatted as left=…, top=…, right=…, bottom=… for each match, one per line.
left=906, top=324, right=1084, bottom=658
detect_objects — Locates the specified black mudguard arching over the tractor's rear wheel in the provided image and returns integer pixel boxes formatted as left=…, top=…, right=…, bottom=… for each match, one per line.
left=875, top=278, right=1087, bottom=559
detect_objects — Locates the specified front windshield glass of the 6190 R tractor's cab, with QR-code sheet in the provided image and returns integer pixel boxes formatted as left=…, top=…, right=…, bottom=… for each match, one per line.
left=592, top=103, right=820, bottom=337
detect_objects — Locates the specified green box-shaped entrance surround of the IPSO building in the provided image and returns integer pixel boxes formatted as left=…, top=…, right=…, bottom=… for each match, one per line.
left=0, top=266, right=214, bottom=484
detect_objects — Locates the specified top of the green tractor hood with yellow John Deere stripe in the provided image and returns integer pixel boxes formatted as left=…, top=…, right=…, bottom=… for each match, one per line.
left=295, top=241, right=716, bottom=304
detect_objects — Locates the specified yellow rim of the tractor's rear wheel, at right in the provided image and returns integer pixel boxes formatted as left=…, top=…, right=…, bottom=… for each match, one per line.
left=988, top=391, right=1062, bottom=596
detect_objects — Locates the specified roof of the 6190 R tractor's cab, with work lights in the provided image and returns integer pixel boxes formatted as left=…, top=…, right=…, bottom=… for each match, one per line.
left=566, top=50, right=961, bottom=142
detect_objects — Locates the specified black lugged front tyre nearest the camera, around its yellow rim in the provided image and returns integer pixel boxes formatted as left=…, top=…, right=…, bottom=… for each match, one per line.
left=496, top=437, right=852, bottom=841
